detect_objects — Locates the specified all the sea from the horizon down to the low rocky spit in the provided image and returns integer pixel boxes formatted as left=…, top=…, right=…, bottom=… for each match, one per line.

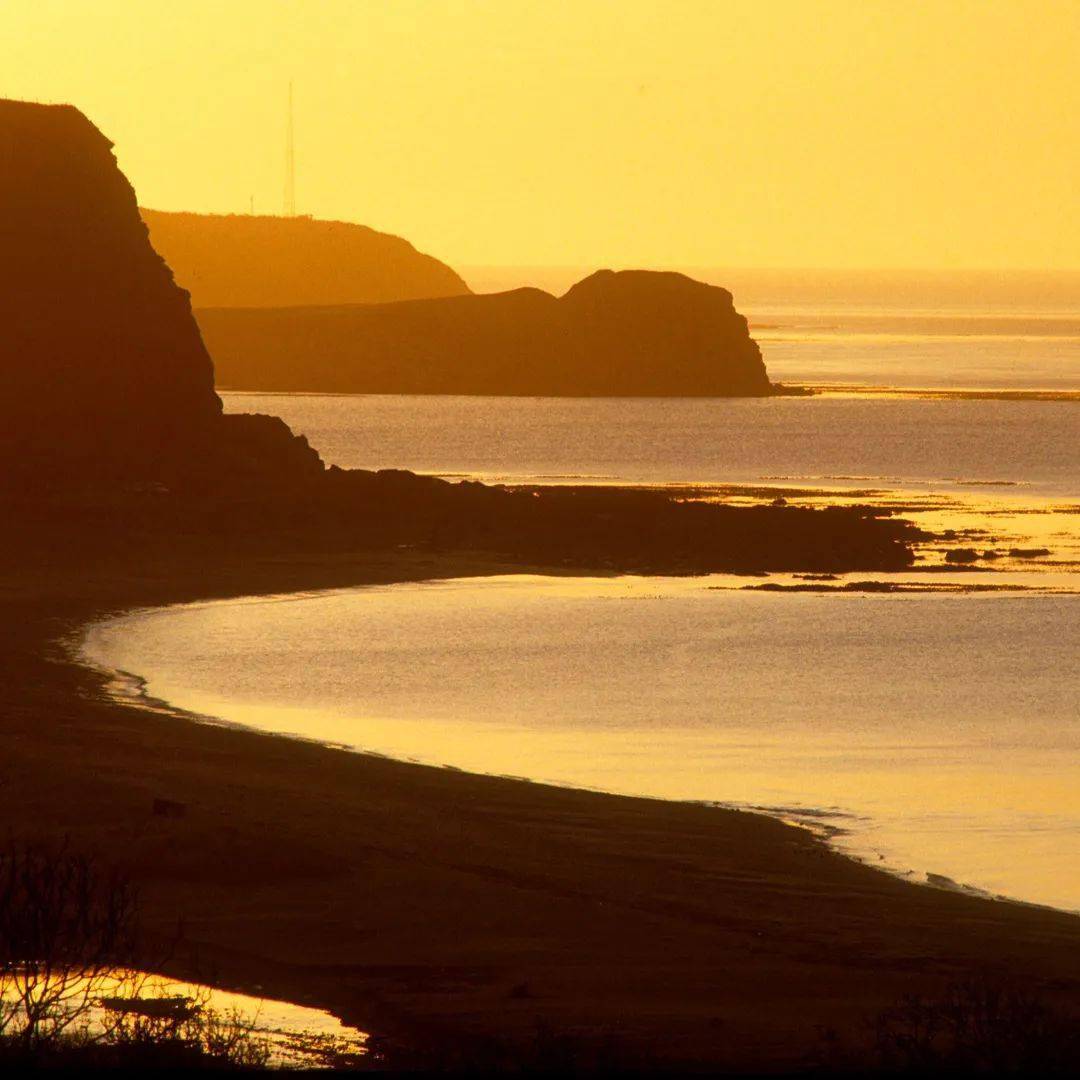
left=222, top=267, right=1080, bottom=499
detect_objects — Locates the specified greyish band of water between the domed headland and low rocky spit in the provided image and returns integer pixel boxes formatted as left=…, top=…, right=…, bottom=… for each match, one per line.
left=222, top=393, right=1080, bottom=499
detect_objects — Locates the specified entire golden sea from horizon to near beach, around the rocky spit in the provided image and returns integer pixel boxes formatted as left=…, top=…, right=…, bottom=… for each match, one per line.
left=82, top=268, right=1080, bottom=910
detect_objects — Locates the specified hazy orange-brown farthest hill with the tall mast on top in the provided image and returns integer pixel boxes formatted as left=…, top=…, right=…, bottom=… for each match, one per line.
left=141, top=208, right=469, bottom=308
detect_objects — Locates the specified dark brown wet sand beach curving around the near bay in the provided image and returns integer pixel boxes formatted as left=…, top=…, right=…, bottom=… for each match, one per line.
left=0, top=540, right=1080, bottom=1069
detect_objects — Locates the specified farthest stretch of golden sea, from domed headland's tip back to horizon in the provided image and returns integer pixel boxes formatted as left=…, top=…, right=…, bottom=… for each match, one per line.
left=464, top=267, right=1080, bottom=390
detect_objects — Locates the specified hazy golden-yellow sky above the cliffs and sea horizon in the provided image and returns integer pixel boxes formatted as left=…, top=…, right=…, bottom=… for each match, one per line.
left=0, top=0, right=1080, bottom=269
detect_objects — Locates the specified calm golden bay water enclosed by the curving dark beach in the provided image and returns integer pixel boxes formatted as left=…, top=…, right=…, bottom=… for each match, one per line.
left=85, top=577, right=1080, bottom=908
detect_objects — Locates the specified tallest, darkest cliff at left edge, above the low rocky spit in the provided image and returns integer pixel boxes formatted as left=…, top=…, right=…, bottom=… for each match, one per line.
left=0, top=100, right=322, bottom=490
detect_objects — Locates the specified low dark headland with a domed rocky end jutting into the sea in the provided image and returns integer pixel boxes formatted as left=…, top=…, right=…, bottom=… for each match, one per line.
left=197, top=270, right=777, bottom=396
